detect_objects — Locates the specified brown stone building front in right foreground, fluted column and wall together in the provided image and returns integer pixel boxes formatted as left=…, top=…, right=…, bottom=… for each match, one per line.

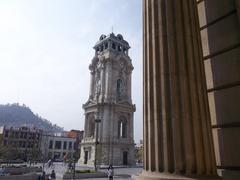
left=137, top=0, right=240, bottom=180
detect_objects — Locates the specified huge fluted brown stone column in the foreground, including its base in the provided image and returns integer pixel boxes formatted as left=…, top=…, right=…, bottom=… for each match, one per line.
left=138, top=0, right=220, bottom=180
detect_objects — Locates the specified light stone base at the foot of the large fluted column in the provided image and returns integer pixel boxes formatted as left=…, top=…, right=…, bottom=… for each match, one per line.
left=132, top=171, right=222, bottom=180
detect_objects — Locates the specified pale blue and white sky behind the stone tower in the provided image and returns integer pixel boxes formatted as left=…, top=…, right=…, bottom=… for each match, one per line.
left=0, top=0, right=143, bottom=143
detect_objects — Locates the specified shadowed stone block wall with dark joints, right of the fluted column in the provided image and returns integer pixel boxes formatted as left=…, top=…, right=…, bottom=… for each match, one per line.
left=198, top=0, right=240, bottom=179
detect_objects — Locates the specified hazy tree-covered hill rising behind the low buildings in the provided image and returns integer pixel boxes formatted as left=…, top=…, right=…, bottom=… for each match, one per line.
left=0, top=103, right=63, bottom=132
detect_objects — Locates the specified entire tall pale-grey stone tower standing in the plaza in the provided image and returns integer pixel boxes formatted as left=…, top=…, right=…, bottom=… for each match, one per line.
left=79, top=33, right=135, bottom=166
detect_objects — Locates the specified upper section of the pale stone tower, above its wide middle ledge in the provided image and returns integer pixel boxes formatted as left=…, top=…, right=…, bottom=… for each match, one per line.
left=89, top=33, right=133, bottom=103
